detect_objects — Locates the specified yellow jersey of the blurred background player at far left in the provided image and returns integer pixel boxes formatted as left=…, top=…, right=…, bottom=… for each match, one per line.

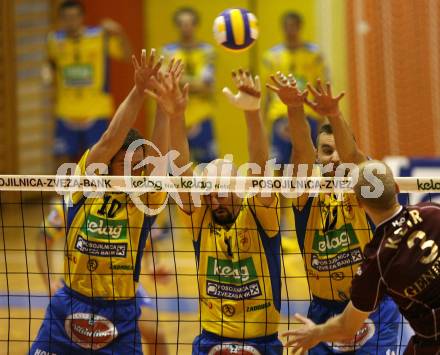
left=48, top=27, right=124, bottom=122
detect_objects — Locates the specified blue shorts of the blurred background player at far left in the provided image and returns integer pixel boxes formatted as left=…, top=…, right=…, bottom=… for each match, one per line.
left=54, top=118, right=109, bottom=160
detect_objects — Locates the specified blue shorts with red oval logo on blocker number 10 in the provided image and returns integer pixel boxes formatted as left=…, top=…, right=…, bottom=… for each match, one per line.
left=29, top=286, right=142, bottom=355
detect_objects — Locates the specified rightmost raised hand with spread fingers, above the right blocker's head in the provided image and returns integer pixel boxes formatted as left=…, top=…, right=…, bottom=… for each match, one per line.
left=305, top=79, right=345, bottom=117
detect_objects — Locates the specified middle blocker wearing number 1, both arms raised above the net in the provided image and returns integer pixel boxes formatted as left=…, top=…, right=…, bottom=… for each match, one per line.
left=144, top=70, right=283, bottom=355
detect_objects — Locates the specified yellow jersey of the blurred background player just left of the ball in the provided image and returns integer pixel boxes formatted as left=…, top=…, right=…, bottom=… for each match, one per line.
left=162, top=43, right=215, bottom=127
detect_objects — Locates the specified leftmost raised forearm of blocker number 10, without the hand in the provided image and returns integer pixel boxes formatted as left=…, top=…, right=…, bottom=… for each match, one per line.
left=87, top=88, right=144, bottom=164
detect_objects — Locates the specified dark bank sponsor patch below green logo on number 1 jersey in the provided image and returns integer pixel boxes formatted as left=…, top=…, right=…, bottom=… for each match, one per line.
left=206, top=281, right=261, bottom=300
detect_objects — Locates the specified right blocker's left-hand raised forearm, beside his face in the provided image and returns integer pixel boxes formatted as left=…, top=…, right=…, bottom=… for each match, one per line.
left=287, top=106, right=315, bottom=166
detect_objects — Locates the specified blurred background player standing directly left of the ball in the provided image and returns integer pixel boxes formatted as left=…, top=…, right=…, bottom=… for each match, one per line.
left=162, top=7, right=217, bottom=163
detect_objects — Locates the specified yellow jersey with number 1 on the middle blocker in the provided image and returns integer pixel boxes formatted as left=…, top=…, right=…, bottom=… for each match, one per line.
left=187, top=199, right=281, bottom=339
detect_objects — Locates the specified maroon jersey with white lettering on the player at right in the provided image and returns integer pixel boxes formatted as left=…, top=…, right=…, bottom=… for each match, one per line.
left=351, top=203, right=440, bottom=341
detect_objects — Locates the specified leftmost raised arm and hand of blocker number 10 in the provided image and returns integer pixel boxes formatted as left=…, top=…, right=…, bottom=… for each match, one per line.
left=86, top=49, right=162, bottom=170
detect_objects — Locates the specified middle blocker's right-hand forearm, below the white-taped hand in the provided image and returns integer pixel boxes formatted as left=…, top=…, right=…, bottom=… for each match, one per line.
left=245, top=110, right=269, bottom=175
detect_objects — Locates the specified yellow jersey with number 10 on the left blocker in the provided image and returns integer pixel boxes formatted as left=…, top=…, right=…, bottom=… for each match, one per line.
left=64, top=151, right=164, bottom=300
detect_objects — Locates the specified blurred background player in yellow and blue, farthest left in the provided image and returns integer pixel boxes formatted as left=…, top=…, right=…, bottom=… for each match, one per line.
left=48, top=0, right=131, bottom=167
